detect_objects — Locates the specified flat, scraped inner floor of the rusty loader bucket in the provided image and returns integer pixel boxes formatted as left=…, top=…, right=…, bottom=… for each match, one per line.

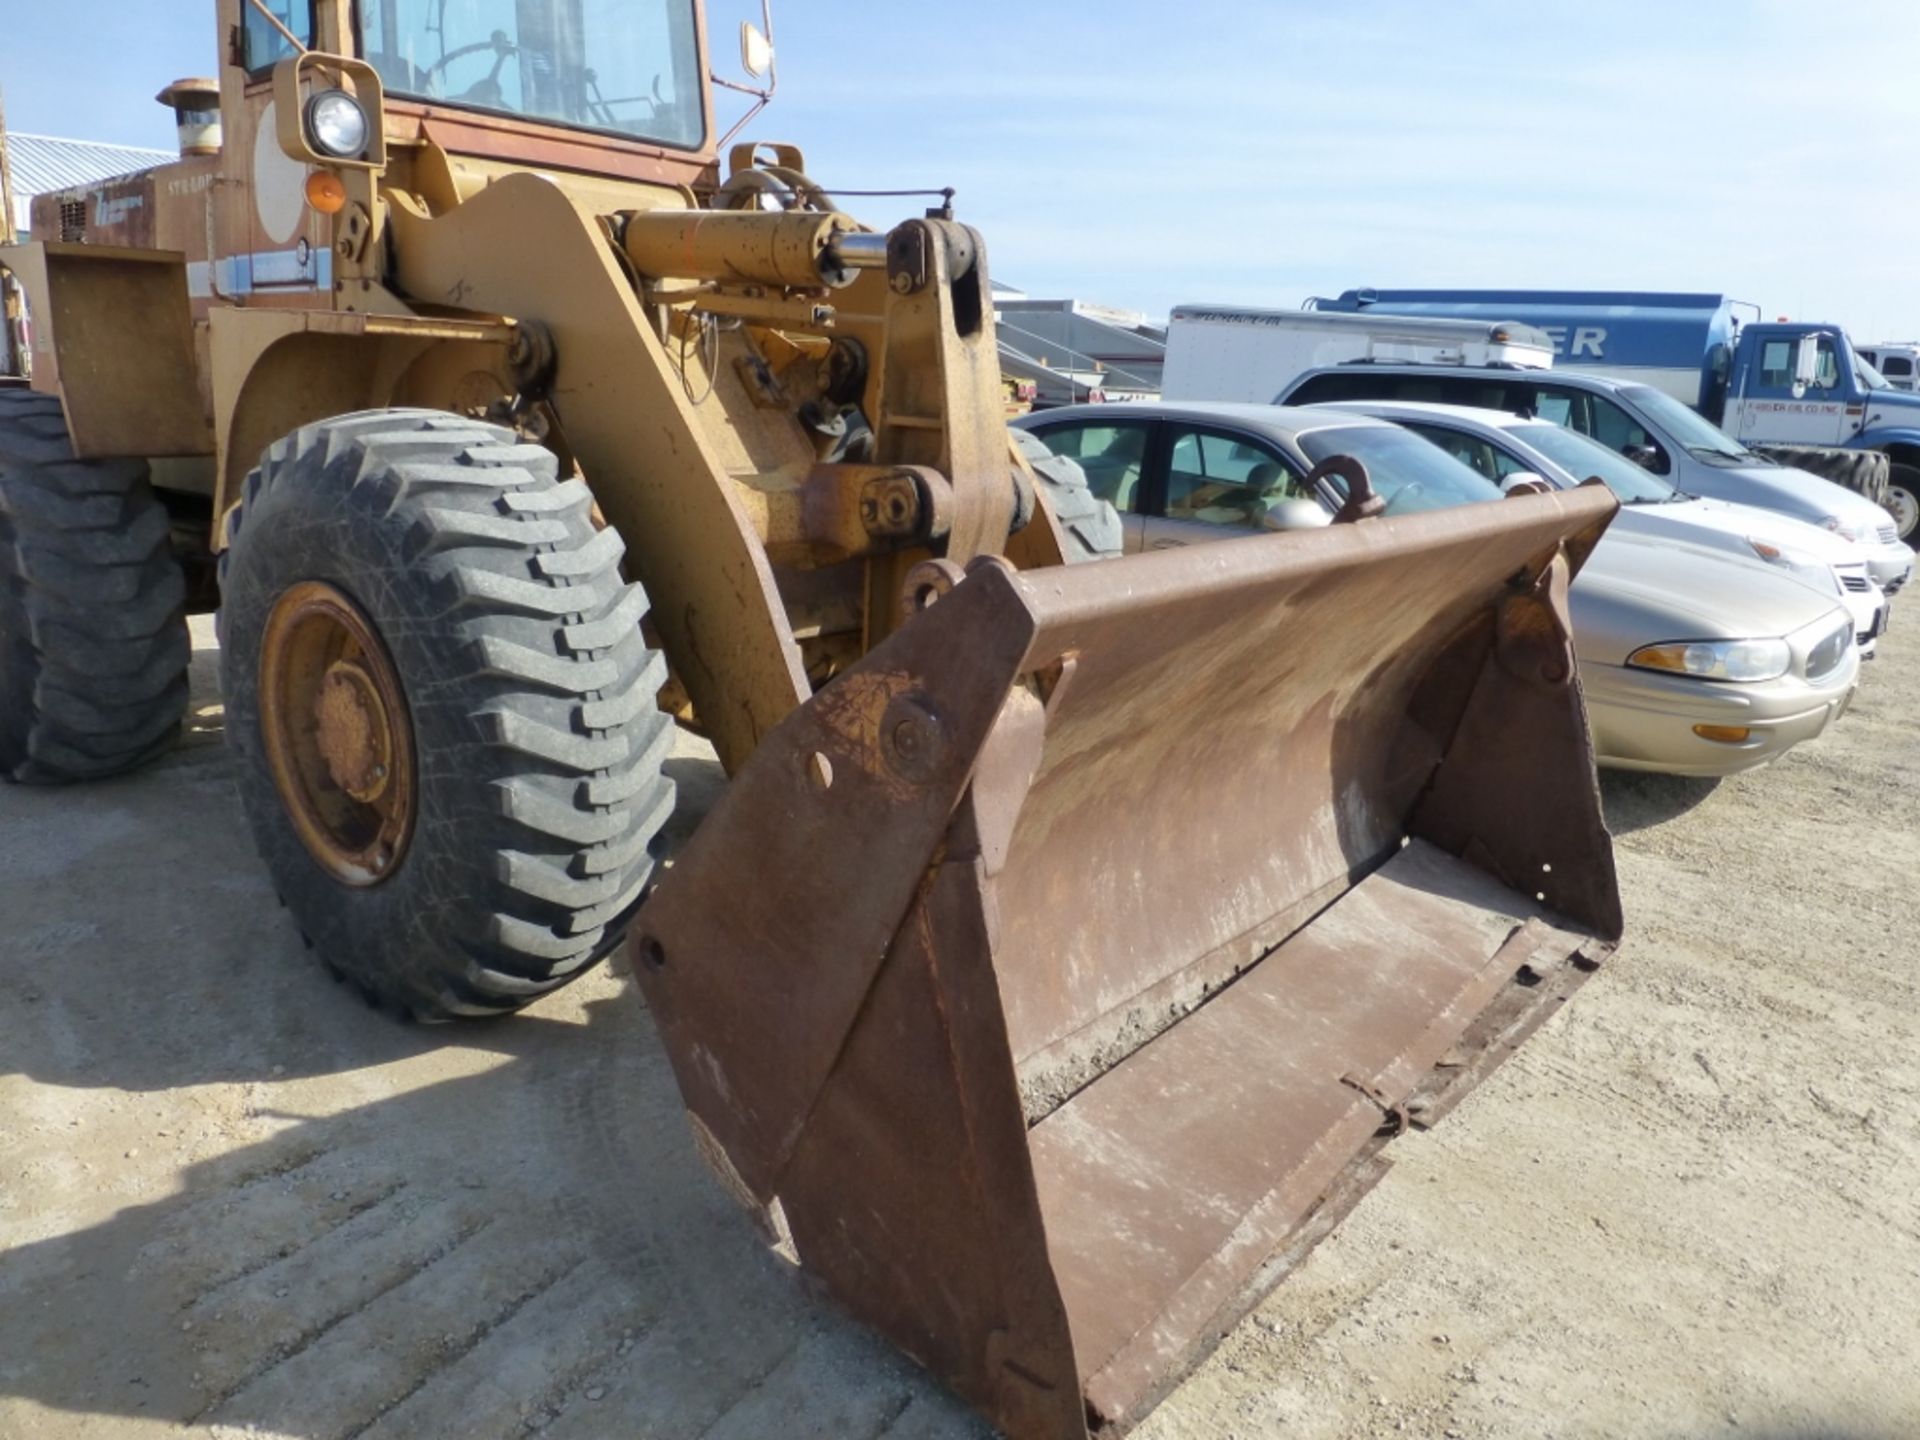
left=1033, top=867, right=1582, bottom=1423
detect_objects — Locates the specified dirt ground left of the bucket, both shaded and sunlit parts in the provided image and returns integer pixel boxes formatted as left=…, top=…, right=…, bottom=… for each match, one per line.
left=0, top=653, right=985, bottom=1440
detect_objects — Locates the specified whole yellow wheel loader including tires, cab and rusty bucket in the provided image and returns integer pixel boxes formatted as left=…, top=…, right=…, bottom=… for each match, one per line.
left=0, top=0, right=1620, bottom=1440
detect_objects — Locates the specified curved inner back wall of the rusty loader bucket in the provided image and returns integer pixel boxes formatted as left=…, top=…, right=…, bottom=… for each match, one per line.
left=1000, top=485, right=1613, bottom=1091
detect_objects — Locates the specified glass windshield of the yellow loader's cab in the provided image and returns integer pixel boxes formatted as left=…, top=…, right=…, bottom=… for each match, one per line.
left=359, top=0, right=705, bottom=148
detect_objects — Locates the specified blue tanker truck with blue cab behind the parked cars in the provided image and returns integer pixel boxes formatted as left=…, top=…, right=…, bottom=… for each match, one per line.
left=1308, top=290, right=1920, bottom=549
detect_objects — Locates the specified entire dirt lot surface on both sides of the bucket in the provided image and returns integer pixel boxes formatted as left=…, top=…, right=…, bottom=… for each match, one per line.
left=0, top=603, right=1920, bottom=1440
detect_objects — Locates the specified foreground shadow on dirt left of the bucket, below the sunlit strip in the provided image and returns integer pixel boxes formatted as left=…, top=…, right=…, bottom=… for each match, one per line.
left=0, top=981, right=981, bottom=1440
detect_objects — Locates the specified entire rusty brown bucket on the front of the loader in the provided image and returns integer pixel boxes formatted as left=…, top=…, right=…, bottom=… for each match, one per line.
left=632, top=488, right=1620, bottom=1440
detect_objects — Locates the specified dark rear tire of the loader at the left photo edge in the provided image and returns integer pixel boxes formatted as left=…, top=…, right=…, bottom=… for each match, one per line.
left=0, top=390, right=192, bottom=783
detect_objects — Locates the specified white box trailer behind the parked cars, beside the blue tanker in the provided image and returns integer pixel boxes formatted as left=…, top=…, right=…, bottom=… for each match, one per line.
left=1160, top=305, right=1553, bottom=405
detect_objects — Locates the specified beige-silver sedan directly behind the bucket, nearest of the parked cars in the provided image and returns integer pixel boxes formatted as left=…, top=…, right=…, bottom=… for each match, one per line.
left=1014, top=403, right=1860, bottom=776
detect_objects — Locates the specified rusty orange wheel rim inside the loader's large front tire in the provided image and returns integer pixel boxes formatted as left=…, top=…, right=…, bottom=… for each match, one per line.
left=259, top=580, right=417, bottom=887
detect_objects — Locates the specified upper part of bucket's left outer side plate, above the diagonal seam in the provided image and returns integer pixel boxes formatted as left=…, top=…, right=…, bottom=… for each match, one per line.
left=636, top=580, right=1033, bottom=1200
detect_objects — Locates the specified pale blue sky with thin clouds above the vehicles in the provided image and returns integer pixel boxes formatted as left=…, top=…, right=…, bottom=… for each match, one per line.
left=0, top=0, right=1920, bottom=342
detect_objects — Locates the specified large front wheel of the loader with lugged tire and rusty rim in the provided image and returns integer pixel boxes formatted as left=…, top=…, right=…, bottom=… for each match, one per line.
left=221, top=411, right=674, bottom=1020
